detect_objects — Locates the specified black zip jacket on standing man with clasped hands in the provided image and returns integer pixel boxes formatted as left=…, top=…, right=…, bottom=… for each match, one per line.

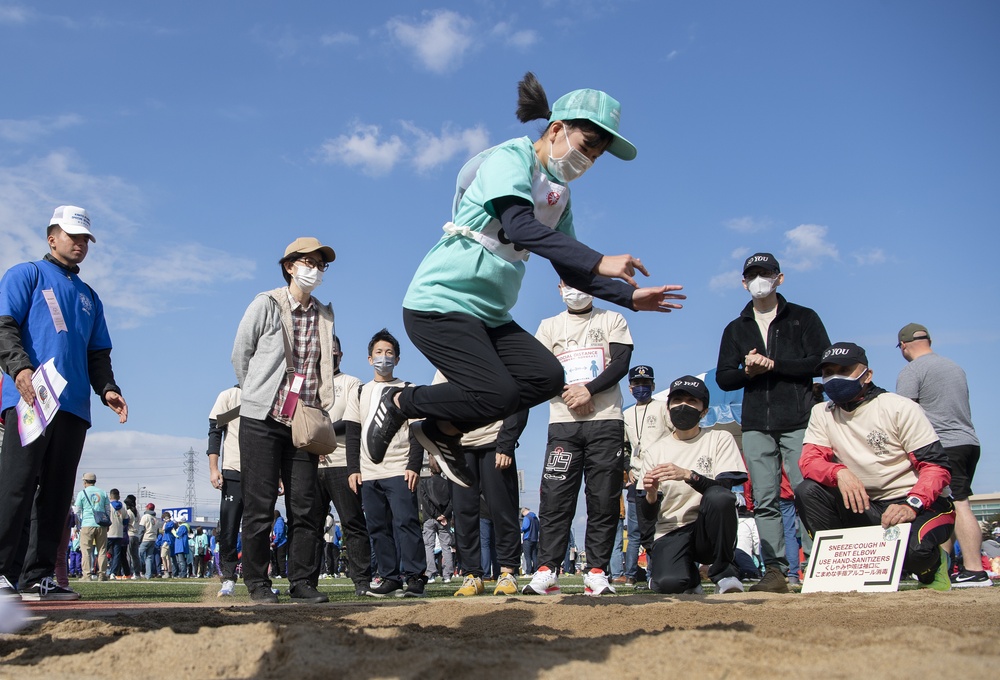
left=715, top=294, right=830, bottom=432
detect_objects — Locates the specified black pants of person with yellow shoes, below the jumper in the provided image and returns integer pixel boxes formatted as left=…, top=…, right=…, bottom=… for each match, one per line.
left=451, top=444, right=521, bottom=578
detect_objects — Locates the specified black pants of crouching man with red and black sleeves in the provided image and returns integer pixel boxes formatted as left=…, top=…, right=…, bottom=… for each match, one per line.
left=795, top=479, right=955, bottom=583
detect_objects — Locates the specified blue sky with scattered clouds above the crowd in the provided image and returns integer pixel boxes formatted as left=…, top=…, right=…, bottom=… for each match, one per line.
left=0, top=0, right=1000, bottom=537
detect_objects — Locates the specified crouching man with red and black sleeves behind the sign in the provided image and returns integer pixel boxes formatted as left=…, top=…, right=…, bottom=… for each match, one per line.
left=795, top=342, right=955, bottom=590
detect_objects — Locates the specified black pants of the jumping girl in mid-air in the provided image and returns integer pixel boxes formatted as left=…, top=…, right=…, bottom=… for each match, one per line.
left=399, top=309, right=565, bottom=432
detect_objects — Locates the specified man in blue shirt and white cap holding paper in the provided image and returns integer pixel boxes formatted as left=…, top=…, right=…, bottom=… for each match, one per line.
left=0, top=205, right=128, bottom=600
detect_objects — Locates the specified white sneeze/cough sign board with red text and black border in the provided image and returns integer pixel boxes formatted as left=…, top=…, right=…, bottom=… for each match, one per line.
left=802, top=524, right=910, bottom=593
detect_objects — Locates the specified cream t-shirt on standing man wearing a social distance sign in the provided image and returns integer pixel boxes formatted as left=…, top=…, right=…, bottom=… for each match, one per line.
left=535, top=307, right=633, bottom=423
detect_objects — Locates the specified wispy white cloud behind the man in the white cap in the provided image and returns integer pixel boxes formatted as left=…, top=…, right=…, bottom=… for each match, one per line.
left=0, top=151, right=255, bottom=327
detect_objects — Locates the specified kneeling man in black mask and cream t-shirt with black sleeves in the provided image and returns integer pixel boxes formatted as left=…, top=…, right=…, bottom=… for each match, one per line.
left=638, top=375, right=747, bottom=593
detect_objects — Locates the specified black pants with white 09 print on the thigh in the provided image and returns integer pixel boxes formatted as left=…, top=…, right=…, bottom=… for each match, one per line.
left=538, top=420, right=625, bottom=573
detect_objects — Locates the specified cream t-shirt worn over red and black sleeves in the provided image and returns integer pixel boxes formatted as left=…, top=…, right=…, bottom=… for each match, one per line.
left=802, top=392, right=951, bottom=501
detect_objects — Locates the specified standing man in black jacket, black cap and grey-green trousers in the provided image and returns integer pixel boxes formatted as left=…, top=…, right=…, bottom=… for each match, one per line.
left=715, top=253, right=830, bottom=593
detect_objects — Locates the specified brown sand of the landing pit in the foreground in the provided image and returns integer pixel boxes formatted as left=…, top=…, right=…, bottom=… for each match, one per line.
left=0, top=587, right=1000, bottom=680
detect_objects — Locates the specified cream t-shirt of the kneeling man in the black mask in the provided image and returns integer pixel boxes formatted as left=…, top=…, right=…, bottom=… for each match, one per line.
left=639, top=429, right=747, bottom=539
